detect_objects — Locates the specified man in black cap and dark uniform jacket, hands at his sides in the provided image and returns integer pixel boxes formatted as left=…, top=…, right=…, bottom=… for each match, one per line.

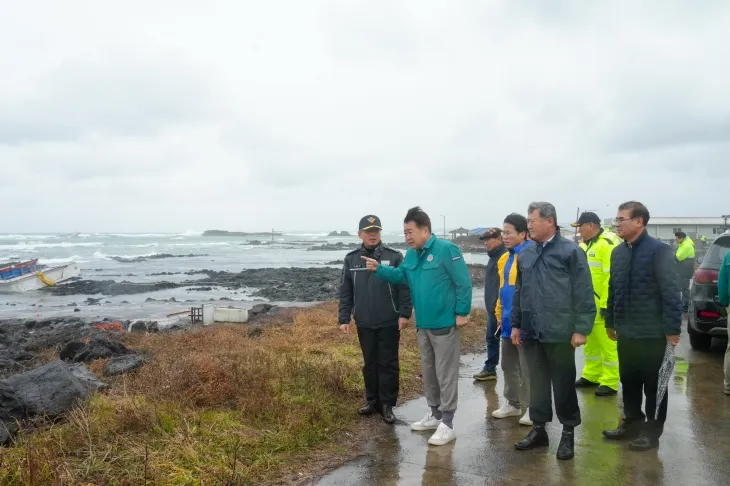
left=339, top=215, right=413, bottom=424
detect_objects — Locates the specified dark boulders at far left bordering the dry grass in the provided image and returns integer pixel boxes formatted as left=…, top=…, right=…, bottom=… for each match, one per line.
left=0, top=303, right=293, bottom=446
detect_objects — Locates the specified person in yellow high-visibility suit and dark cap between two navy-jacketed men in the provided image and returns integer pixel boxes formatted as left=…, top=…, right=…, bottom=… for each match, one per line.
left=572, top=212, right=620, bottom=397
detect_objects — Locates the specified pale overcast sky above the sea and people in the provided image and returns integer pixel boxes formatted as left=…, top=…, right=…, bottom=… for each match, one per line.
left=0, top=0, right=730, bottom=233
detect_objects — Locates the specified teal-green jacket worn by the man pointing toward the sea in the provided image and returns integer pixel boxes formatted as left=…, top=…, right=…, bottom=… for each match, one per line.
left=375, top=235, right=472, bottom=329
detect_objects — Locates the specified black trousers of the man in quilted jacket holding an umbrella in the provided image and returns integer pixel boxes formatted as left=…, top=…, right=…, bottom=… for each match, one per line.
left=618, top=338, right=669, bottom=439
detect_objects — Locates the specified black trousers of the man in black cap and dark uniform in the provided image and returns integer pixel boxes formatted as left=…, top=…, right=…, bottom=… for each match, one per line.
left=357, top=324, right=400, bottom=407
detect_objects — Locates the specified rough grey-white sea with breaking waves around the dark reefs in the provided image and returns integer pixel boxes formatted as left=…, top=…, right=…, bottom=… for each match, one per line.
left=0, top=231, right=488, bottom=320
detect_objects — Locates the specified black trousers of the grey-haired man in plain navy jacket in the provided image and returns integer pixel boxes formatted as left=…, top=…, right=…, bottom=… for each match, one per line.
left=522, top=340, right=580, bottom=427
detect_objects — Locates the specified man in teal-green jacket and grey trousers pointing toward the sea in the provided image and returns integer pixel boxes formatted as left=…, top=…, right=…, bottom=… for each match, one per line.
left=363, top=206, right=472, bottom=445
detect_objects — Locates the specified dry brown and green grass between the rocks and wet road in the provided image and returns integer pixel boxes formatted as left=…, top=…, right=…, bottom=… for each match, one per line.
left=0, top=303, right=484, bottom=486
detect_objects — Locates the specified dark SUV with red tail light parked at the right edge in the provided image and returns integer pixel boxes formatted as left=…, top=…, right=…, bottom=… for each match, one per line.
left=687, top=232, right=730, bottom=349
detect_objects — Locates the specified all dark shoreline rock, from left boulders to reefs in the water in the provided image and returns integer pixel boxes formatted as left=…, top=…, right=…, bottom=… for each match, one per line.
left=0, top=261, right=484, bottom=444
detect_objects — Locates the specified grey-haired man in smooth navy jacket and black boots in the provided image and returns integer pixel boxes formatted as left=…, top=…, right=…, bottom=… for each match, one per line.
left=510, top=202, right=596, bottom=460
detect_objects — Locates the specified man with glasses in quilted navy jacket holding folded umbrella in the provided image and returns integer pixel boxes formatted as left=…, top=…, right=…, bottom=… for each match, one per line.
left=603, top=201, right=682, bottom=451
